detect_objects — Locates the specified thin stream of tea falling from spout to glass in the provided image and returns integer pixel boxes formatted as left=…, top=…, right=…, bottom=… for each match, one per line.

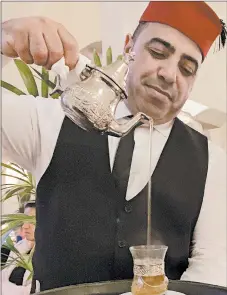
left=147, top=119, right=154, bottom=245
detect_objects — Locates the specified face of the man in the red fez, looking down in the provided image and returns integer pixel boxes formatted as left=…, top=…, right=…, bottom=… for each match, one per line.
left=126, top=23, right=202, bottom=124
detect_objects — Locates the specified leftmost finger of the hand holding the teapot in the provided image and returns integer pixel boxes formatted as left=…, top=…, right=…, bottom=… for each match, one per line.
left=14, top=32, right=33, bottom=64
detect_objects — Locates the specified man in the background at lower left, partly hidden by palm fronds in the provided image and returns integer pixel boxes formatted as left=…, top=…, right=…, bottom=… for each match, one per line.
left=1, top=202, right=36, bottom=295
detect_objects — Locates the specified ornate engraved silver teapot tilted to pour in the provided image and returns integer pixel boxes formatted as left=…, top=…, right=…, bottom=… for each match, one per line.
left=53, top=53, right=150, bottom=137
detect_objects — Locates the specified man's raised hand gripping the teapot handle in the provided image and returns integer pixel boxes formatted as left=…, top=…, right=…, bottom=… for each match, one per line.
left=1, top=17, right=79, bottom=70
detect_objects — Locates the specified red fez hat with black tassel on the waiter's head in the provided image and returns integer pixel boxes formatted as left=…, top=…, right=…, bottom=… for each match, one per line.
left=140, top=1, right=226, bottom=57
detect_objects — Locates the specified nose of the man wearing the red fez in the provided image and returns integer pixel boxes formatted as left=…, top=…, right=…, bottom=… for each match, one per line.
left=158, top=60, right=177, bottom=85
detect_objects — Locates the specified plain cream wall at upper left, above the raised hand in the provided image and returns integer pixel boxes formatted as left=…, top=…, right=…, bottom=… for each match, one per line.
left=2, top=2, right=101, bottom=90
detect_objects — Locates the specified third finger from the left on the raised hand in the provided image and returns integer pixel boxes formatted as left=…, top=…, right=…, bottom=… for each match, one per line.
left=43, top=29, right=64, bottom=70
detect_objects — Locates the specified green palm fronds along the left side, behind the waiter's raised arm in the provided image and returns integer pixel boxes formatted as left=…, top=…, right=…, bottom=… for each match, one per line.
left=1, top=59, right=56, bottom=279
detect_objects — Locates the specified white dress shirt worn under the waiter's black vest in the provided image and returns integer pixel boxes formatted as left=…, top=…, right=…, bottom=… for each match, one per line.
left=2, top=56, right=227, bottom=286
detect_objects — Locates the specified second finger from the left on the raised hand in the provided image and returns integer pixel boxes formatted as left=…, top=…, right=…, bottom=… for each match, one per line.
left=29, top=31, right=48, bottom=66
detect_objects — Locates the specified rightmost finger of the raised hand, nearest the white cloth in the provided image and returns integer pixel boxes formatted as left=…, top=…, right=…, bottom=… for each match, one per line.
left=58, top=26, right=79, bottom=70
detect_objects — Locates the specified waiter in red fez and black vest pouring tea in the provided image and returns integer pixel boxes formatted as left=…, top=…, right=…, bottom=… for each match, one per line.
left=2, top=1, right=227, bottom=290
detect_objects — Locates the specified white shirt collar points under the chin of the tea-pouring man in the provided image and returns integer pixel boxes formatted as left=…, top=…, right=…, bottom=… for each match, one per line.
left=115, top=101, right=174, bottom=137
